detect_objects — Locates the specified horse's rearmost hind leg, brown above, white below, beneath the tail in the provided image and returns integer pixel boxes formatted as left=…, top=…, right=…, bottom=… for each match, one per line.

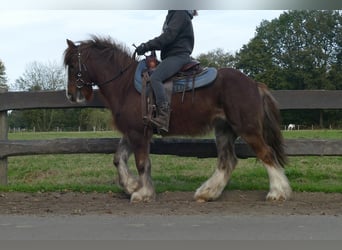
left=244, top=135, right=292, bottom=201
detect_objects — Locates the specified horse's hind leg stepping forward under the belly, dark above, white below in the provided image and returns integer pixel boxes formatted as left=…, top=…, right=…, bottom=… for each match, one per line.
left=194, top=120, right=237, bottom=202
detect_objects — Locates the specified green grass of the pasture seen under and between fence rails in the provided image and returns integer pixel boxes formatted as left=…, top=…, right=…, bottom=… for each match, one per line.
left=0, top=130, right=342, bottom=192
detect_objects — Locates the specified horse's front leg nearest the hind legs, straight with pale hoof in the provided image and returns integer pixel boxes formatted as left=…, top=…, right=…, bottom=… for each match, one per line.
left=131, top=137, right=156, bottom=202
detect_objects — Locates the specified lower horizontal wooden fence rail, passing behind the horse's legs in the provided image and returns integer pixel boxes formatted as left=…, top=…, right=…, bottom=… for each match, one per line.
left=0, top=138, right=342, bottom=158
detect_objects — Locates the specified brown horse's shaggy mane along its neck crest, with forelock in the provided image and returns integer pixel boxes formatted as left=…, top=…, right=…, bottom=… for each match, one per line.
left=64, top=35, right=132, bottom=65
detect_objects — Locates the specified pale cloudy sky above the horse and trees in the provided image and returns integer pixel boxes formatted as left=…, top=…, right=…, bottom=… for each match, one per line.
left=0, top=9, right=284, bottom=88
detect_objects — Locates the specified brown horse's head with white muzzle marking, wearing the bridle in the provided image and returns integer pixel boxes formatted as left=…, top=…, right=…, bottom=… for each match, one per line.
left=64, top=40, right=94, bottom=103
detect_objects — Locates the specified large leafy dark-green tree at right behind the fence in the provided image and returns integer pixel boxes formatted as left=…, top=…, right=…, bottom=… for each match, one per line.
left=236, top=10, right=342, bottom=89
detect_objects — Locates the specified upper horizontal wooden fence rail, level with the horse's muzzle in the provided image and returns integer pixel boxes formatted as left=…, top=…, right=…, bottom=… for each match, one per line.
left=0, top=90, right=342, bottom=111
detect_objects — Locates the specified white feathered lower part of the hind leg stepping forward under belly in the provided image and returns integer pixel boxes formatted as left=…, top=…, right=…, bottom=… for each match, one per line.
left=194, top=168, right=230, bottom=202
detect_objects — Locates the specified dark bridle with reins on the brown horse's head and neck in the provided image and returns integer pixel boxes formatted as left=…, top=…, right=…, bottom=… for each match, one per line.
left=76, top=45, right=133, bottom=89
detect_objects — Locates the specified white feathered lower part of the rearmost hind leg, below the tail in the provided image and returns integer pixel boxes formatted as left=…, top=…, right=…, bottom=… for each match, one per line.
left=265, top=165, right=292, bottom=200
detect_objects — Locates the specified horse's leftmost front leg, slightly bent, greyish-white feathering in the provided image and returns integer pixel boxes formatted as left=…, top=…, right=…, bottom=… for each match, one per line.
left=114, top=137, right=139, bottom=194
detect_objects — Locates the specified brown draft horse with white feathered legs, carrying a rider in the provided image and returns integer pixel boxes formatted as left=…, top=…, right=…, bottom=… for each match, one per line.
left=64, top=36, right=291, bottom=202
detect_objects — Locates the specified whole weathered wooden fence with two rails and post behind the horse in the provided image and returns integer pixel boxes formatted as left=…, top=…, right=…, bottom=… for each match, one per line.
left=0, top=88, right=342, bottom=185
